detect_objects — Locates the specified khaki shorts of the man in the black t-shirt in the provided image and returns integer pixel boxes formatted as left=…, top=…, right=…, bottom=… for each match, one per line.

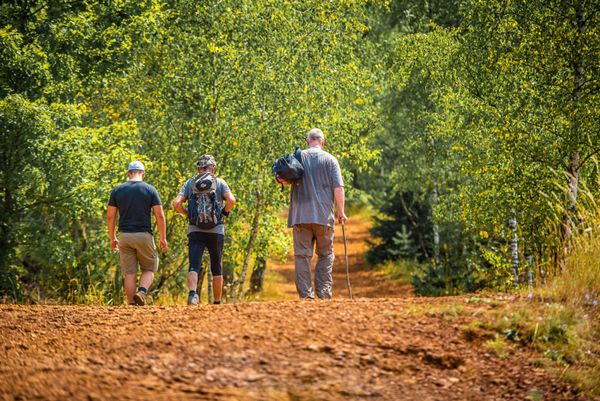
left=119, top=232, right=158, bottom=274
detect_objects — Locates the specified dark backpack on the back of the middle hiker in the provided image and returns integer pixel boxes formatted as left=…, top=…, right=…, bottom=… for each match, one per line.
left=188, top=172, right=223, bottom=229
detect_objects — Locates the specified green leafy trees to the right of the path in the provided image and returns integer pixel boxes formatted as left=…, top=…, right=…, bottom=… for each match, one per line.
left=365, top=0, right=600, bottom=288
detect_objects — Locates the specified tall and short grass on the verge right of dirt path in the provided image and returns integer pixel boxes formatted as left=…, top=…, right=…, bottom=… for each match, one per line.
left=463, top=219, right=600, bottom=396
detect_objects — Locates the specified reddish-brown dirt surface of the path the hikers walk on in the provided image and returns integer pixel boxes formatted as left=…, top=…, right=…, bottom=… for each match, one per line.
left=0, top=219, right=585, bottom=401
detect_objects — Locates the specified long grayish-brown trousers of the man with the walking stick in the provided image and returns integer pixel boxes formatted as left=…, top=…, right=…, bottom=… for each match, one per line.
left=294, top=224, right=334, bottom=299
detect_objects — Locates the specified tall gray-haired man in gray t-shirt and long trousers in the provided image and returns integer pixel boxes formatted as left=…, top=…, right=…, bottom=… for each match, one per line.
left=288, top=128, right=348, bottom=299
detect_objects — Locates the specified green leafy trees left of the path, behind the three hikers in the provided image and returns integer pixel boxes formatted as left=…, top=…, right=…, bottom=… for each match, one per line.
left=0, top=0, right=378, bottom=303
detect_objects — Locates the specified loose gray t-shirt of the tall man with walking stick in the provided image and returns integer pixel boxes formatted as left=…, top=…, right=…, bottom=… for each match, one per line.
left=288, top=148, right=344, bottom=227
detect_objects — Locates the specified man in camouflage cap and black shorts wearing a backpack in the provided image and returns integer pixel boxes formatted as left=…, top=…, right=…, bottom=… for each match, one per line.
left=173, top=155, right=235, bottom=305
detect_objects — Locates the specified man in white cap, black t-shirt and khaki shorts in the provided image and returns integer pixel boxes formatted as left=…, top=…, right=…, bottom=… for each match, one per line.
left=106, top=161, right=168, bottom=306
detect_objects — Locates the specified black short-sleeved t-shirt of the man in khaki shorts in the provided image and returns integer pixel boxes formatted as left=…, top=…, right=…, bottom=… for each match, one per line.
left=108, top=181, right=161, bottom=234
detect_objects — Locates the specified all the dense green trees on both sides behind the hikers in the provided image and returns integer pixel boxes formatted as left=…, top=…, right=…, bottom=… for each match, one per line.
left=0, top=0, right=600, bottom=303
